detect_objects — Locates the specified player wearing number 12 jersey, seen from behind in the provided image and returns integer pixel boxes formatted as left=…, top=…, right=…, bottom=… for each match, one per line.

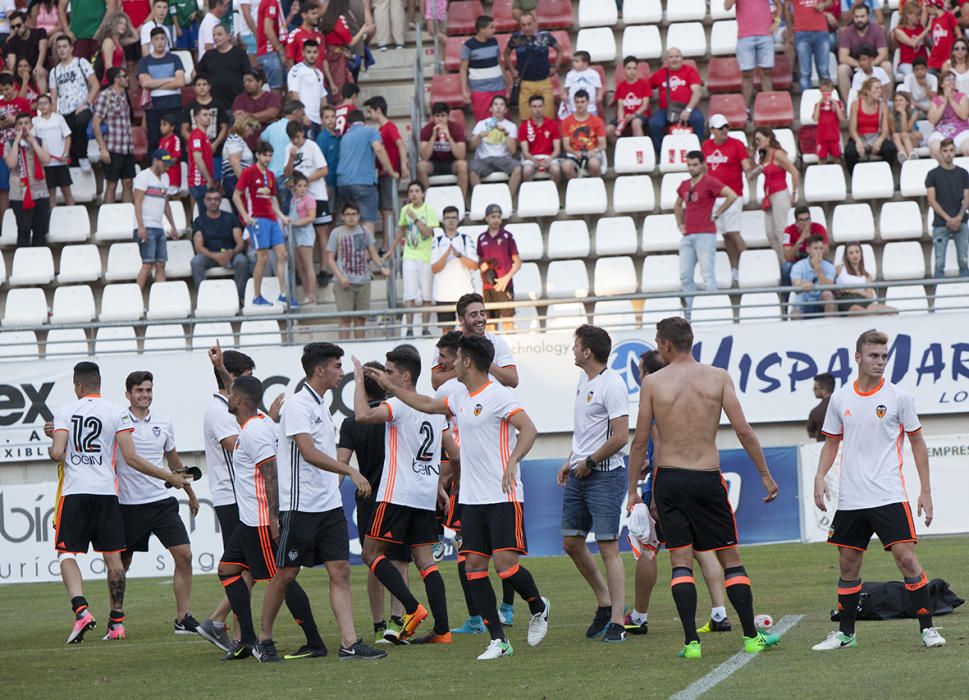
left=48, top=362, right=187, bottom=644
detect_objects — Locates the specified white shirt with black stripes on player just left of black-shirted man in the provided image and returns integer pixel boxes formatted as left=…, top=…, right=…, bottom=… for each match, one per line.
left=276, top=384, right=343, bottom=513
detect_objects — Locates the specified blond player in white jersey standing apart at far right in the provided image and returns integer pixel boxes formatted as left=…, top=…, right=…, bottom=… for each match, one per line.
left=813, top=330, right=945, bottom=651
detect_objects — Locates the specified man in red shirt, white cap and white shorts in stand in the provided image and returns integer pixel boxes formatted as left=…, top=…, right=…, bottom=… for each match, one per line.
left=700, top=114, right=754, bottom=283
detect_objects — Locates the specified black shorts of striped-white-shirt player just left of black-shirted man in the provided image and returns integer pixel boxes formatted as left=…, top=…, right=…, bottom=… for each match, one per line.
left=276, top=506, right=350, bottom=569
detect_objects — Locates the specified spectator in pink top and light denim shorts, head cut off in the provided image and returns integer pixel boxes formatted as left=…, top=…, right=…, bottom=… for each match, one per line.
left=723, top=0, right=781, bottom=110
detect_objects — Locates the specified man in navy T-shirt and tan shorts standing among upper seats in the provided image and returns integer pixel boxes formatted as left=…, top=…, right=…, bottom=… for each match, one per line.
left=504, top=12, right=562, bottom=119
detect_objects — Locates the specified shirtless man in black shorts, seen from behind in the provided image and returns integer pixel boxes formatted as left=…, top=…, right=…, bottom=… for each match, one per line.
left=627, top=317, right=778, bottom=659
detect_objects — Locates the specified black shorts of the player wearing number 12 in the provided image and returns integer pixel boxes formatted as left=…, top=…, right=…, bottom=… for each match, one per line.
left=54, top=493, right=125, bottom=554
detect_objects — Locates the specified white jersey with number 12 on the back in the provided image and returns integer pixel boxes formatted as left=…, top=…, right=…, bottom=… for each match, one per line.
left=54, top=394, right=135, bottom=496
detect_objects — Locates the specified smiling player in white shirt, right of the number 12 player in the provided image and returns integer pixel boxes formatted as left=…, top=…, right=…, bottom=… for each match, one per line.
left=118, top=371, right=199, bottom=634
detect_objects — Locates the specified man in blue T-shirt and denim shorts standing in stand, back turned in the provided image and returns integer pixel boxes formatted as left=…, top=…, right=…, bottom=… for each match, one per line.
left=336, top=109, right=400, bottom=239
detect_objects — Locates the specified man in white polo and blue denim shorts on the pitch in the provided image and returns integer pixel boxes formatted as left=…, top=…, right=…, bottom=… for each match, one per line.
left=557, top=325, right=629, bottom=642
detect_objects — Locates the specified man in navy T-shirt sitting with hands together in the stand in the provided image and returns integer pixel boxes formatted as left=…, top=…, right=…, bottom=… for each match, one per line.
left=191, top=187, right=249, bottom=306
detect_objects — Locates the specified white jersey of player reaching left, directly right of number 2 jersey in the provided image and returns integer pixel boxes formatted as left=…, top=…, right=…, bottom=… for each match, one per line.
left=444, top=380, right=525, bottom=505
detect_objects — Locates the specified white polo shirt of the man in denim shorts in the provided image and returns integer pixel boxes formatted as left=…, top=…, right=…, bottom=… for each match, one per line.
left=572, top=368, right=629, bottom=470
